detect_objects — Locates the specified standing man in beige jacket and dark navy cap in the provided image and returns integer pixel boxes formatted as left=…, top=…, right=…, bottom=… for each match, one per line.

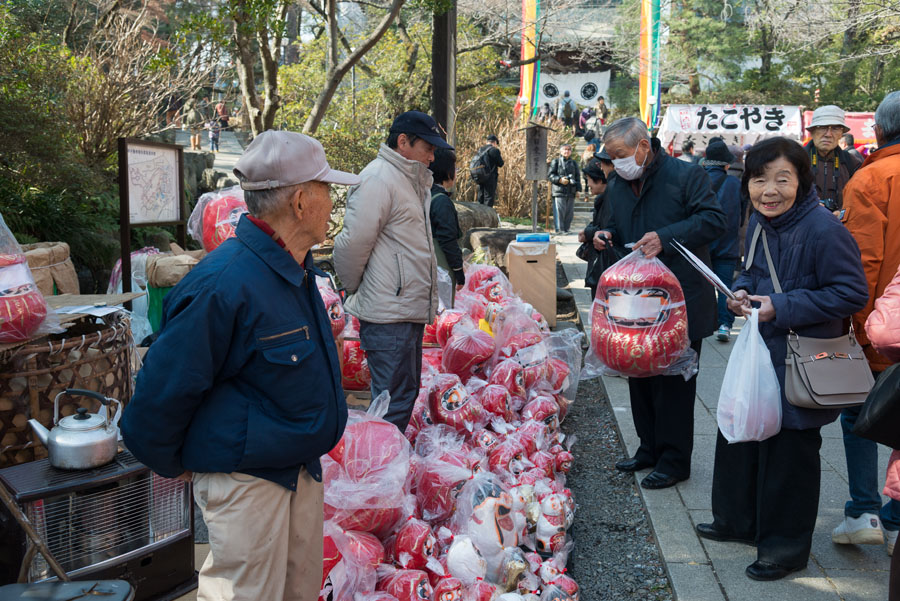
left=334, top=111, right=453, bottom=432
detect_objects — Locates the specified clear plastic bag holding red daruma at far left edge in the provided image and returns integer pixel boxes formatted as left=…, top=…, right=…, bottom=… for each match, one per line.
left=0, top=215, right=63, bottom=344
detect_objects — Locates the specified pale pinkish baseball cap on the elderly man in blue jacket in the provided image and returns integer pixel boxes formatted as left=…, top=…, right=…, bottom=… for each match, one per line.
left=234, top=130, right=360, bottom=190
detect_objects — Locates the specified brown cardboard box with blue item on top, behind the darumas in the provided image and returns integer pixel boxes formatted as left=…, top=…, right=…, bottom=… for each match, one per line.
left=506, top=242, right=556, bottom=328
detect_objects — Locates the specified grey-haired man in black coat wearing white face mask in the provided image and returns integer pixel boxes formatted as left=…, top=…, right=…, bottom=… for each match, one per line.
left=603, top=117, right=726, bottom=488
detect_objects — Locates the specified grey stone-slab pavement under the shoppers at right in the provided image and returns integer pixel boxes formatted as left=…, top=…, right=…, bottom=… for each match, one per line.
left=554, top=203, right=890, bottom=601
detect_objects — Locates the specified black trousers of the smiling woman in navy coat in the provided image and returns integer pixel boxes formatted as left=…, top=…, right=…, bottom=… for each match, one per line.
left=712, top=428, right=822, bottom=567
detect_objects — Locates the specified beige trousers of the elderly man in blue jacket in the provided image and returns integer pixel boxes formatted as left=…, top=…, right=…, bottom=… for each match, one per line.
left=194, top=470, right=324, bottom=601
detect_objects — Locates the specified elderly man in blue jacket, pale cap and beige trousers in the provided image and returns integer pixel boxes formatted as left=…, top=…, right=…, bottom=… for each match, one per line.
left=121, top=131, right=359, bottom=601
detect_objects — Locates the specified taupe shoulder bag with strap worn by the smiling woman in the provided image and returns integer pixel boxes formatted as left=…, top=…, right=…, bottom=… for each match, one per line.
left=747, top=224, right=875, bottom=409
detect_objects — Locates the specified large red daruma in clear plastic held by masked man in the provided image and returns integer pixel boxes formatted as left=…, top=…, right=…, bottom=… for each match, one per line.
left=591, top=251, right=690, bottom=377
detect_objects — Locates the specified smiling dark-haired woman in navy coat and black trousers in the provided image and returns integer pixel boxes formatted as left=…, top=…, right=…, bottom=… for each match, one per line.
left=696, top=138, right=868, bottom=580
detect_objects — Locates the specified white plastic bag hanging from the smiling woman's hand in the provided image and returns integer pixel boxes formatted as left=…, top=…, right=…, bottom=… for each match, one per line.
left=716, top=309, right=781, bottom=443
